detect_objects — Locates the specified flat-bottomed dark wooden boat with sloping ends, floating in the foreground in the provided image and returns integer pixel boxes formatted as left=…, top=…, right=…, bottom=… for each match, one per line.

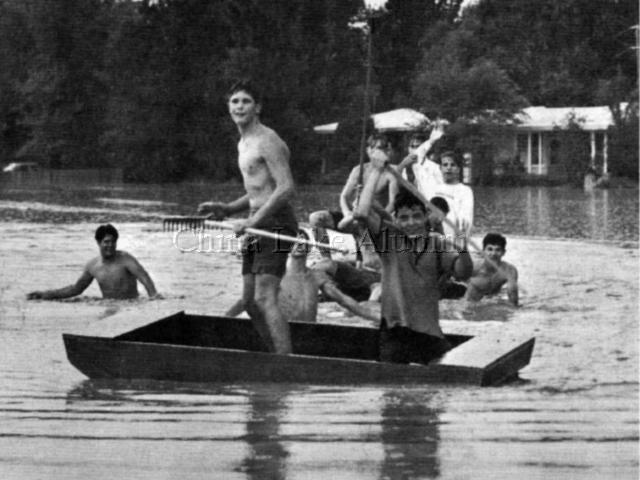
left=63, top=312, right=534, bottom=385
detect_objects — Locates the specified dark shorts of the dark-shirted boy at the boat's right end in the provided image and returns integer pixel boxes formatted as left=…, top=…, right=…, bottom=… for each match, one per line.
left=380, top=319, right=451, bottom=364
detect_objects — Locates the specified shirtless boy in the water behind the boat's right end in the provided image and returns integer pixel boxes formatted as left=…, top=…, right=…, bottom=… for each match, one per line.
left=465, top=233, right=518, bottom=306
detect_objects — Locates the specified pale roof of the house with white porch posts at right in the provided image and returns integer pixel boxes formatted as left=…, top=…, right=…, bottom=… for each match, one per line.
left=515, top=106, right=614, bottom=131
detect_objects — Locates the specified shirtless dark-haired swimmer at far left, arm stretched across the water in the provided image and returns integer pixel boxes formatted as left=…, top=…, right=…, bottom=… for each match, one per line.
left=27, top=224, right=162, bottom=300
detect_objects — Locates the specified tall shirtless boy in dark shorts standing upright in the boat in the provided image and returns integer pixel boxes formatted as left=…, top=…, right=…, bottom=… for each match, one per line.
left=198, top=81, right=298, bottom=354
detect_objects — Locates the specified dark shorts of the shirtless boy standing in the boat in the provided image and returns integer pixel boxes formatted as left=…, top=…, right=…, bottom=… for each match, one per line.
left=242, top=205, right=298, bottom=277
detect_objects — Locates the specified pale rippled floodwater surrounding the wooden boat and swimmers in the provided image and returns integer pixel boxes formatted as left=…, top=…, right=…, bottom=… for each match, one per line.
left=0, top=183, right=638, bottom=479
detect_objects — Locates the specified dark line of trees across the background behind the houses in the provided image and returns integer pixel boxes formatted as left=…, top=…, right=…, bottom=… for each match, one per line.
left=0, top=0, right=638, bottom=182
